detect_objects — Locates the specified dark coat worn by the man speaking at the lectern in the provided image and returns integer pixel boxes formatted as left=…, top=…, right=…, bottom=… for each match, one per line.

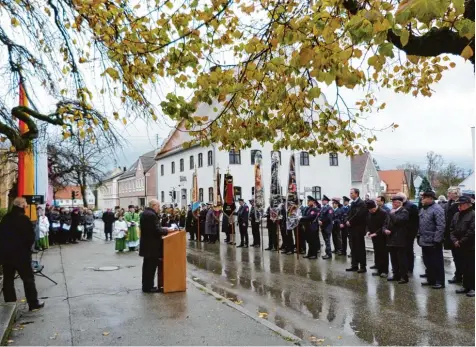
left=139, top=207, right=167, bottom=258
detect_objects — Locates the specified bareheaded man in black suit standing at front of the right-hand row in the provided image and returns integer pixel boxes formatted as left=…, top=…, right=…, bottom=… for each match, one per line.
left=345, top=188, right=368, bottom=273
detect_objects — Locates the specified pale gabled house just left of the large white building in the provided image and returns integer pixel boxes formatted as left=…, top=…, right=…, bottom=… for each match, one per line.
left=117, top=150, right=157, bottom=208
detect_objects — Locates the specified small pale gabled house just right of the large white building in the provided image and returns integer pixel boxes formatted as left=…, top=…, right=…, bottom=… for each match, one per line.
left=351, top=153, right=381, bottom=199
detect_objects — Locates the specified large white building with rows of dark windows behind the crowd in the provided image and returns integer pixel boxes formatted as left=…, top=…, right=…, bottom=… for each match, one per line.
left=156, top=119, right=351, bottom=207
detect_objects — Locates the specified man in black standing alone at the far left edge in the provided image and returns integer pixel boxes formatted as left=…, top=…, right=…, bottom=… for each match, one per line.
left=0, top=198, right=45, bottom=311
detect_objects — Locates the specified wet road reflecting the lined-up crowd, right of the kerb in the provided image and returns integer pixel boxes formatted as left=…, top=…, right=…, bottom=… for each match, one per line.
left=187, top=242, right=475, bottom=346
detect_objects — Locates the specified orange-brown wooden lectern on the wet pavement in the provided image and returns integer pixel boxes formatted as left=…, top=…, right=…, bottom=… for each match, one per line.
left=162, top=230, right=187, bottom=293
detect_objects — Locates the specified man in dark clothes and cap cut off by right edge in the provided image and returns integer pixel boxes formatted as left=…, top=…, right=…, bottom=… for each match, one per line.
left=450, top=196, right=474, bottom=298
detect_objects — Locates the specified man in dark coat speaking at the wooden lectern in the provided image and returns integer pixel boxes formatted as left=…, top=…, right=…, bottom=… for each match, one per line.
left=139, top=199, right=175, bottom=293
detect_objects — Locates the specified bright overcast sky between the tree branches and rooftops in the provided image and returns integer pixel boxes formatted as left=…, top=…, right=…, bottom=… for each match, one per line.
left=113, top=57, right=476, bottom=173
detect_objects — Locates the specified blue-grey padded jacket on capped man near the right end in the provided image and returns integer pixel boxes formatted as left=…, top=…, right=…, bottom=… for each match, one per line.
left=418, top=203, right=445, bottom=247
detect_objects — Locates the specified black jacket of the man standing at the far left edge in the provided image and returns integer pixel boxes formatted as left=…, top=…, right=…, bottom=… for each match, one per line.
left=0, top=206, right=35, bottom=264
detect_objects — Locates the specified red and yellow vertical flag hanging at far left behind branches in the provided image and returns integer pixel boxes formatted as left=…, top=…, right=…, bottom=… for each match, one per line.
left=18, top=83, right=37, bottom=221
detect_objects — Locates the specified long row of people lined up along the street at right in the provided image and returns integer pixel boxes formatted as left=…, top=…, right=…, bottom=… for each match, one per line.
left=181, top=188, right=475, bottom=297
